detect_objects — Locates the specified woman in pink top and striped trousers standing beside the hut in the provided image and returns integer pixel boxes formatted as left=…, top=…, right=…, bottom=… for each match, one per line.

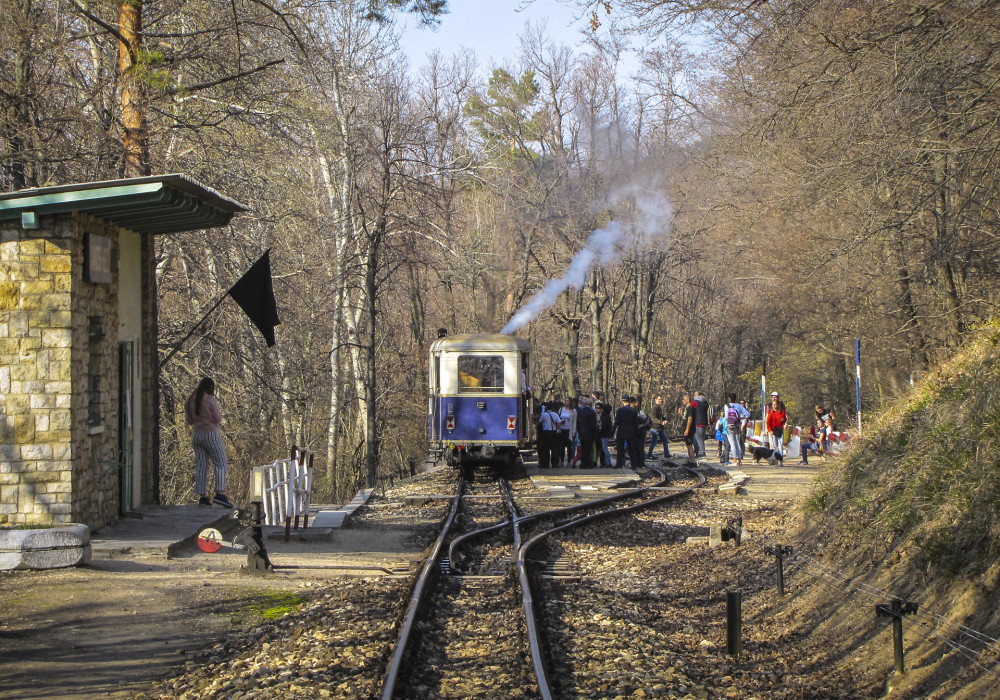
left=184, top=377, right=233, bottom=508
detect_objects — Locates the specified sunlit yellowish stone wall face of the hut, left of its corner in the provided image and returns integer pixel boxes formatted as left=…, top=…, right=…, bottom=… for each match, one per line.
left=0, top=218, right=74, bottom=524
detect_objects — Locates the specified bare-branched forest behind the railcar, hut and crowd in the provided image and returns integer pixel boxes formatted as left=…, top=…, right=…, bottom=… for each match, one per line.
left=0, top=0, right=1000, bottom=503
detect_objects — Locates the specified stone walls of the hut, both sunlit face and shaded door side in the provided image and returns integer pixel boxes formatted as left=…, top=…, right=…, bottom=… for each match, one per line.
left=0, top=214, right=118, bottom=529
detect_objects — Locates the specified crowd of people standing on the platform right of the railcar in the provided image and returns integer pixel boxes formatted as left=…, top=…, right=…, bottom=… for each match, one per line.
left=535, top=391, right=838, bottom=469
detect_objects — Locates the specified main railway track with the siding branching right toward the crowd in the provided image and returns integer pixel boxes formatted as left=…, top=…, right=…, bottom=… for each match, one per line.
left=381, top=462, right=704, bottom=700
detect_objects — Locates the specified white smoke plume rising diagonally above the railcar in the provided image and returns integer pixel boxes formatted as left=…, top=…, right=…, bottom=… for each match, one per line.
left=500, top=183, right=673, bottom=335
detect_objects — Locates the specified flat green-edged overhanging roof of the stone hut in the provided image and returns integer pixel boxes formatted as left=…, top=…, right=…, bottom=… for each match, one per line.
left=0, top=174, right=247, bottom=235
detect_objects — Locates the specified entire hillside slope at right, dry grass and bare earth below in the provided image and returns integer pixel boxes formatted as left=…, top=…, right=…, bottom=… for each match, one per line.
left=787, top=324, right=1000, bottom=699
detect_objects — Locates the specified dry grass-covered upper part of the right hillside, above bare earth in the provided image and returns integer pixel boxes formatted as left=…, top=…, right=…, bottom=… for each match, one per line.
left=807, top=325, right=1000, bottom=576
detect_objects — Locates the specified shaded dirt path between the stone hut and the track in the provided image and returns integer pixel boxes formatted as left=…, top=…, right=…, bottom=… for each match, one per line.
left=0, top=529, right=419, bottom=700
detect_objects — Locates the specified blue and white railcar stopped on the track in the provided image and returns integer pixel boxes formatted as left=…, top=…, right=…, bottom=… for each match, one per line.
left=428, top=333, right=534, bottom=464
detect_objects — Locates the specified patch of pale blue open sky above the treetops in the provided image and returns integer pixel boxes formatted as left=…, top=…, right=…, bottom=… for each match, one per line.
left=400, top=0, right=624, bottom=74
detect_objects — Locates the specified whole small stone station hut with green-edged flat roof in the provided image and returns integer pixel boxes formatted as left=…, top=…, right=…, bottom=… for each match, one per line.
left=0, top=175, right=245, bottom=529
